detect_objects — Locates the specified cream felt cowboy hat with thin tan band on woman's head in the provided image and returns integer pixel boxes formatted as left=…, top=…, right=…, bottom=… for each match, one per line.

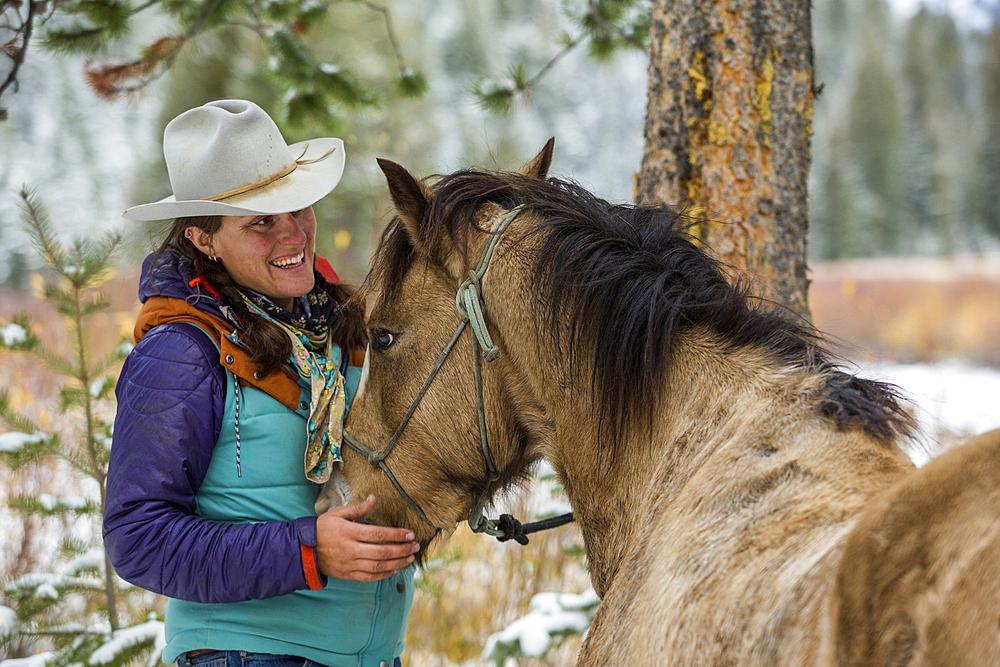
left=122, top=100, right=344, bottom=220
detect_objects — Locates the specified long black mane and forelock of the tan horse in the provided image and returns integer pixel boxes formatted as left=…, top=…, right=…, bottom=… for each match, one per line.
left=369, top=171, right=912, bottom=442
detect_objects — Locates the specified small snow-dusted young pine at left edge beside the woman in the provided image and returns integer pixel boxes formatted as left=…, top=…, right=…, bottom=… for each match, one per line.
left=0, top=190, right=163, bottom=667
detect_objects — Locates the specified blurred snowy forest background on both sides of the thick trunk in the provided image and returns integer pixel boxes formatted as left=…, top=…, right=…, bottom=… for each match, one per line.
left=0, top=0, right=1000, bottom=287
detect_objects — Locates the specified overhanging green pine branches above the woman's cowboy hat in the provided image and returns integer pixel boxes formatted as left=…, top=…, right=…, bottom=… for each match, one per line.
left=0, top=0, right=426, bottom=126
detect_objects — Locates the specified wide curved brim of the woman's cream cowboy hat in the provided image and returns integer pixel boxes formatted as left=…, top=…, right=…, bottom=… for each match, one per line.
left=122, top=137, right=345, bottom=222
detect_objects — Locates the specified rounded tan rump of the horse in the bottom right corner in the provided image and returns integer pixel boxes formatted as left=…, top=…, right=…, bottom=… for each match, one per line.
left=833, top=430, right=1000, bottom=667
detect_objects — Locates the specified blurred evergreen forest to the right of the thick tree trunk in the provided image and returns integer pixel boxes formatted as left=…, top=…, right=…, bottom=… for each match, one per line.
left=810, top=0, right=1000, bottom=260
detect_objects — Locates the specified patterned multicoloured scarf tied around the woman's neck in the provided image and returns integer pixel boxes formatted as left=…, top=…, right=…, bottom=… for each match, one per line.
left=240, top=279, right=346, bottom=484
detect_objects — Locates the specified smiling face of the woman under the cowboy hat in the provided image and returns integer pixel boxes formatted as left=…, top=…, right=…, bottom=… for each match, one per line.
left=191, top=206, right=316, bottom=310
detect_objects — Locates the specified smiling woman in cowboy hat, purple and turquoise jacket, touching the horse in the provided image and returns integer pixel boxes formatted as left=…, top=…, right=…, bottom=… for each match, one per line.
left=104, top=100, right=418, bottom=667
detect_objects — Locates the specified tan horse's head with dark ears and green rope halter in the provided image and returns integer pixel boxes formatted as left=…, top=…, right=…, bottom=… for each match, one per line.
left=343, top=140, right=553, bottom=553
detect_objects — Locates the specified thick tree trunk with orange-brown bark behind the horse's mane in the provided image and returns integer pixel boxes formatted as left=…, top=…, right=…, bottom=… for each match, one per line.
left=637, top=0, right=816, bottom=317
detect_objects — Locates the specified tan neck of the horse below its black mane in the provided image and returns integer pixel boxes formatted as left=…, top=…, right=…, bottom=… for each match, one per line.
left=484, top=221, right=844, bottom=594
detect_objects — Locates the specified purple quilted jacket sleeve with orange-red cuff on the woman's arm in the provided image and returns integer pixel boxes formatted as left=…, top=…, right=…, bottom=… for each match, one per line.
left=104, top=324, right=325, bottom=602
